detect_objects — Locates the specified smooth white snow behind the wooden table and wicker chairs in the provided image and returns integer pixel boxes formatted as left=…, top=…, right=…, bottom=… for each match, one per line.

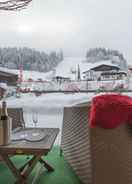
left=6, top=93, right=94, bottom=144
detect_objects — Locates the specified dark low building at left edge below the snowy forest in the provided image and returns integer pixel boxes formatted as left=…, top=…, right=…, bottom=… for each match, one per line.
left=0, top=70, right=18, bottom=86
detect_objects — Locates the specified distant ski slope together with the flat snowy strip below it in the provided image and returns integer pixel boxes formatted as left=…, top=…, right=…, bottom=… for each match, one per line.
left=0, top=57, right=132, bottom=91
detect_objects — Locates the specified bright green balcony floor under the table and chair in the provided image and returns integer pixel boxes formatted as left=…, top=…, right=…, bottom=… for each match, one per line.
left=0, top=146, right=81, bottom=184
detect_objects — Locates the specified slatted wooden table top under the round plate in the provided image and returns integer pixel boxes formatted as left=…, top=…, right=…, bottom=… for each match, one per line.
left=0, top=128, right=59, bottom=154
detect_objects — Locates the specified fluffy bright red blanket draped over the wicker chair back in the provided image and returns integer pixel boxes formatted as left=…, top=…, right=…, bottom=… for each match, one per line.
left=89, top=94, right=132, bottom=128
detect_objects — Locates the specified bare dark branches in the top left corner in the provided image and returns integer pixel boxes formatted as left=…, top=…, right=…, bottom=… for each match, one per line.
left=0, top=0, right=32, bottom=11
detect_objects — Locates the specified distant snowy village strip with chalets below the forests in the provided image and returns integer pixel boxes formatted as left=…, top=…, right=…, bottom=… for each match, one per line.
left=0, top=57, right=132, bottom=96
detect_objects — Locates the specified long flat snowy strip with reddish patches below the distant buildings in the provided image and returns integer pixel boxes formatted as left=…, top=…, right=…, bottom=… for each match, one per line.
left=13, top=80, right=130, bottom=92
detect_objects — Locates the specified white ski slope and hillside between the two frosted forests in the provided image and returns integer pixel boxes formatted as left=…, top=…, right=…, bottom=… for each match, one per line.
left=0, top=57, right=120, bottom=80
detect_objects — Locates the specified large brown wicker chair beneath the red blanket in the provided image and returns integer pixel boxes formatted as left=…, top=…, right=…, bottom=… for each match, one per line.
left=61, top=105, right=132, bottom=184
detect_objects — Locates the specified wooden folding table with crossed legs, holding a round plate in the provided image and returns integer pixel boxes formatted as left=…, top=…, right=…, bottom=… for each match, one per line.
left=0, top=128, right=59, bottom=184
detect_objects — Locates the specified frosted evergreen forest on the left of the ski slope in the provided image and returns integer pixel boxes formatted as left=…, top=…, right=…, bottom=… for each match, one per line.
left=0, top=47, right=63, bottom=72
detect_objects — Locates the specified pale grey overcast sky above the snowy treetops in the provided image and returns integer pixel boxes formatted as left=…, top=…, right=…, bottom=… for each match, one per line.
left=0, top=0, right=132, bottom=63
